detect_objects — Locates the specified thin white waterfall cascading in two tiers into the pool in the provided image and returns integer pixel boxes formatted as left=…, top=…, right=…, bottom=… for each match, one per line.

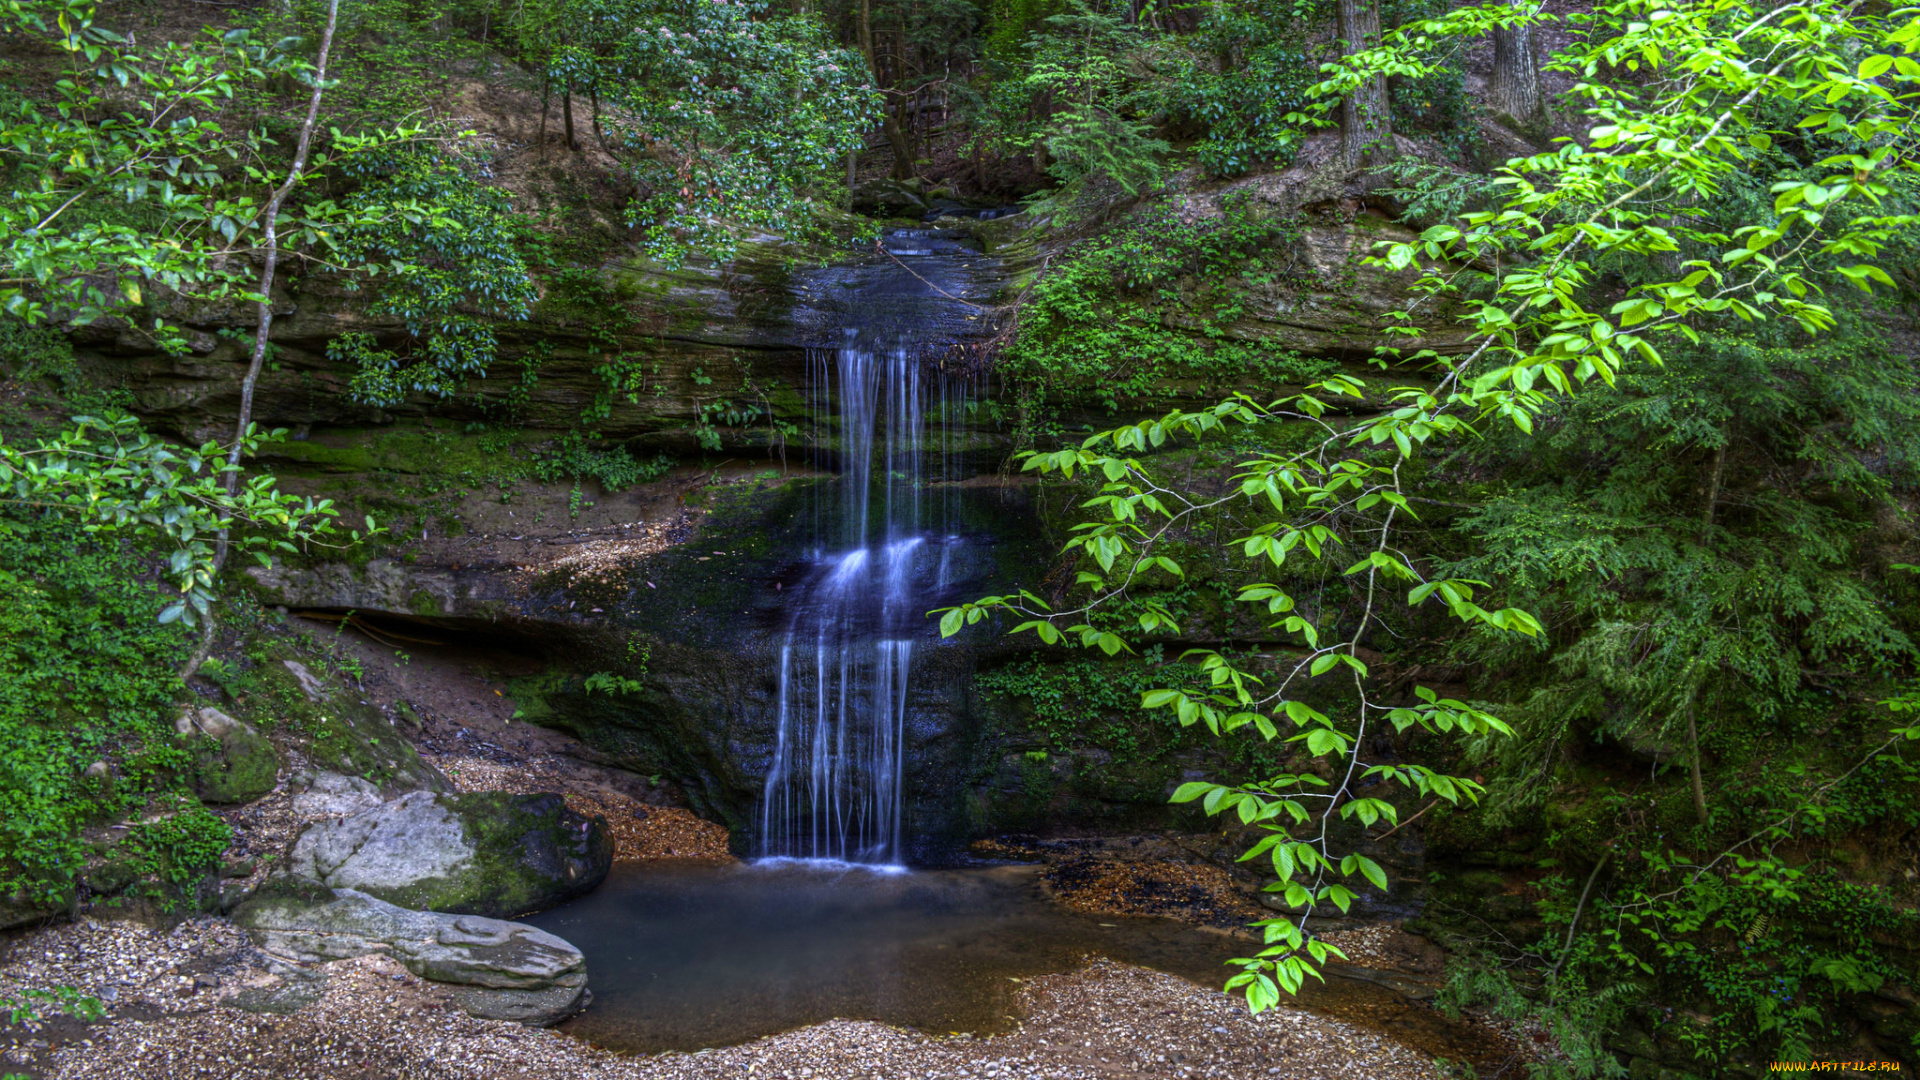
left=758, top=336, right=968, bottom=865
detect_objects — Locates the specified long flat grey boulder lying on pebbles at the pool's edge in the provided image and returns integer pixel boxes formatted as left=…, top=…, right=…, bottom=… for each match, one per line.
left=234, top=882, right=588, bottom=1026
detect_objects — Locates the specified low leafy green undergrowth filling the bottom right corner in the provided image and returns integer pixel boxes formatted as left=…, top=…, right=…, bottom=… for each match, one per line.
left=1569, top=694, right=1920, bottom=1065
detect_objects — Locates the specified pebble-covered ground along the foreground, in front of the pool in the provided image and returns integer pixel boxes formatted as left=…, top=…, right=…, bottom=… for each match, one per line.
left=0, top=919, right=1436, bottom=1080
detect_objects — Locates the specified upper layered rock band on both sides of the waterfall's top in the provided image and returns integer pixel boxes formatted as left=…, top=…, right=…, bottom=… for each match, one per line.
left=77, top=173, right=1465, bottom=453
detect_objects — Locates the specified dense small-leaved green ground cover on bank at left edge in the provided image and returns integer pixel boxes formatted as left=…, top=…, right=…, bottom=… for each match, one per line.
left=0, top=511, right=190, bottom=901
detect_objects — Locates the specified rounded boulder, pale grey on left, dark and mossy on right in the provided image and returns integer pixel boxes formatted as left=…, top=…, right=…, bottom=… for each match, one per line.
left=288, top=792, right=612, bottom=919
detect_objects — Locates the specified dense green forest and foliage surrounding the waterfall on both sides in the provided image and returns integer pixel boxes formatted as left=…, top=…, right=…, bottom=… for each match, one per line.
left=0, top=0, right=1920, bottom=1076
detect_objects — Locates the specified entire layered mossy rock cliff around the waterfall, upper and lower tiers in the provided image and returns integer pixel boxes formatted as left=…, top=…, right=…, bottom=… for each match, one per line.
left=93, top=191, right=1459, bottom=857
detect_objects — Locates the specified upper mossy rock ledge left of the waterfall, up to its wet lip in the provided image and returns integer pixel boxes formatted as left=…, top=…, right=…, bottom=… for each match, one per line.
left=77, top=228, right=1000, bottom=451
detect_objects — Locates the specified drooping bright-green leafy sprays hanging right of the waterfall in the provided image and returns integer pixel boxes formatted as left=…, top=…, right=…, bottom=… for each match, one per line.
left=941, top=377, right=1542, bottom=1011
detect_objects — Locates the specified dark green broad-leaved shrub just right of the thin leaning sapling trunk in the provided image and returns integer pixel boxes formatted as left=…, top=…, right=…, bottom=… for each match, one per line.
left=326, top=146, right=536, bottom=405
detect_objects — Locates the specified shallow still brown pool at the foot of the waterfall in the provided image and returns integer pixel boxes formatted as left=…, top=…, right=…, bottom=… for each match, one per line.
left=528, top=861, right=1480, bottom=1059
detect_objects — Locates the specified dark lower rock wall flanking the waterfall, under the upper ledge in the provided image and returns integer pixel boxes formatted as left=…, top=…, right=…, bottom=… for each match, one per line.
left=250, top=479, right=1048, bottom=853
